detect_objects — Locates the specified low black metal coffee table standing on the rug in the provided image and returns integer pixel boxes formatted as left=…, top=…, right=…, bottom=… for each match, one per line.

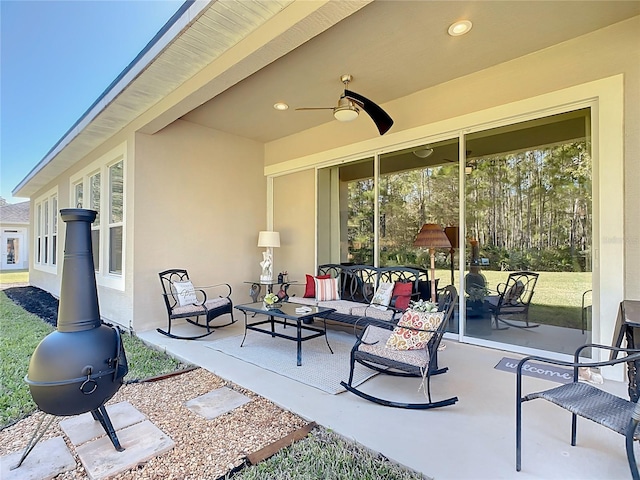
left=235, top=302, right=334, bottom=366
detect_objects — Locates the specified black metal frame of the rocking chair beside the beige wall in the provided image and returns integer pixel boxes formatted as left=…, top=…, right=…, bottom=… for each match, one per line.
left=156, top=268, right=236, bottom=340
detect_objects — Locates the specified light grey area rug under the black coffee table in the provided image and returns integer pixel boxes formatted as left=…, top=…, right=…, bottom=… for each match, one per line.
left=207, top=325, right=376, bottom=395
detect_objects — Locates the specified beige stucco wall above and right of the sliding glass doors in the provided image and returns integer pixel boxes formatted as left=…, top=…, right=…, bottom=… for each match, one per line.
left=265, top=17, right=640, bottom=299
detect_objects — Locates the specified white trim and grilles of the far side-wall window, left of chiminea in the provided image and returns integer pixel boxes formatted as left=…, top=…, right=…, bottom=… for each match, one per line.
left=32, top=188, right=61, bottom=274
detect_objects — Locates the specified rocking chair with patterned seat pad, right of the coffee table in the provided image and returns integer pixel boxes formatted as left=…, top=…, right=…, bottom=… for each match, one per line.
left=340, top=285, right=458, bottom=410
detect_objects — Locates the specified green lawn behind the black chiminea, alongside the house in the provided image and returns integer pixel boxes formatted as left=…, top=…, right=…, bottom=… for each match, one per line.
left=0, top=292, right=181, bottom=429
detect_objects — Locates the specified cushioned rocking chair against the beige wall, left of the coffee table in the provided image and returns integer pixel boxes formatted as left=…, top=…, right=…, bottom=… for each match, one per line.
left=157, top=268, right=235, bottom=340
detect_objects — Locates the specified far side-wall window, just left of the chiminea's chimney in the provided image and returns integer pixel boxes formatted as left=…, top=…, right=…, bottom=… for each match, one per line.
left=34, top=193, right=58, bottom=267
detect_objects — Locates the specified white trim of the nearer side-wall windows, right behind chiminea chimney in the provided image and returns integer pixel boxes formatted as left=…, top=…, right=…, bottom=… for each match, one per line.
left=69, top=142, right=127, bottom=291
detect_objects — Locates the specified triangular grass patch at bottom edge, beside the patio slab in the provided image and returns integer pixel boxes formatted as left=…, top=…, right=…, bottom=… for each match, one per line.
left=228, top=428, right=425, bottom=480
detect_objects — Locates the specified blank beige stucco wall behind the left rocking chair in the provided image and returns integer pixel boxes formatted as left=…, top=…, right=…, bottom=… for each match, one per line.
left=132, top=120, right=266, bottom=331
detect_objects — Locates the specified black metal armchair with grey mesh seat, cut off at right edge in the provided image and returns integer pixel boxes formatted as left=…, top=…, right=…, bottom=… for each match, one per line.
left=516, top=344, right=640, bottom=478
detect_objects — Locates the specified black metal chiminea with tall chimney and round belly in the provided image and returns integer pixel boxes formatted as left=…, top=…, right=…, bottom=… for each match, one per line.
left=25, top=208, right=129, bottom=458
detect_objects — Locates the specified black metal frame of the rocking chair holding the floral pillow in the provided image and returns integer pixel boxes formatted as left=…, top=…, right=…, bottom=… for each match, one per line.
left=340, top=285, right=458, bottom=410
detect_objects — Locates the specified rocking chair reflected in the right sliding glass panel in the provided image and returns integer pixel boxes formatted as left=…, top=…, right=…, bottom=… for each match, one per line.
left=485, top=271, right=539, bottom=330
